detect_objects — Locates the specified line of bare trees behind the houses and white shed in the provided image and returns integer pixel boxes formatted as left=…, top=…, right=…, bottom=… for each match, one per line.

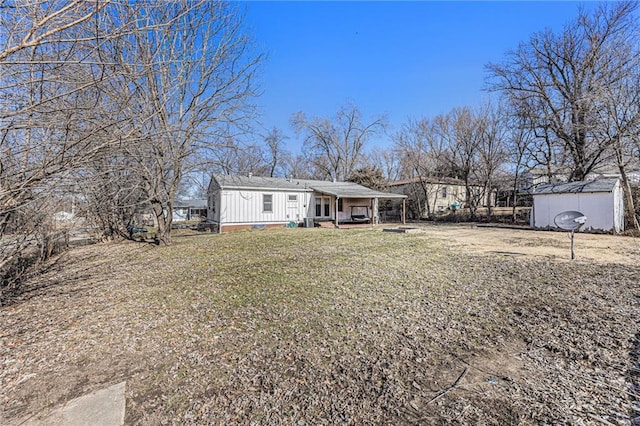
left=284, top=2, right=640, bottom=229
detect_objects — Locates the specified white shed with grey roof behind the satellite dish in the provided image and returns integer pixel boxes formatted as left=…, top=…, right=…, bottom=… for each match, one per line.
left=531, top=179, right=624, bottom=232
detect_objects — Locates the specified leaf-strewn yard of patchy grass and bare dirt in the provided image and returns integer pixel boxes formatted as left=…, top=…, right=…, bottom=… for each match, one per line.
left=0, top=224, right=640, bottom=425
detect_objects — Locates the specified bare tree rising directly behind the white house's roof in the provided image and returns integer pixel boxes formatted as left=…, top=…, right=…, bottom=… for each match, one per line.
left=291, top=105, right=386, bottom=181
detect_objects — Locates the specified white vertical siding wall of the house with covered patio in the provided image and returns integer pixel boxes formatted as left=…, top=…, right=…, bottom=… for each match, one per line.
left=218, top=189, right=310, bottom=225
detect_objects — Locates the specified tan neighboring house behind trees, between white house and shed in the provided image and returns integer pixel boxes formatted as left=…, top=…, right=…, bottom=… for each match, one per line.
left=389, top=177, right=484, bottom=219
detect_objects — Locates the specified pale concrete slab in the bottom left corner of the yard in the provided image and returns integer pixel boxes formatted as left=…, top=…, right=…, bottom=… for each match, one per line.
left=23, top=382, right=126, bottom=426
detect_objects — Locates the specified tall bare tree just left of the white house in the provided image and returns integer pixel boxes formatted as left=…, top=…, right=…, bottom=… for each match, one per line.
left=118, top=0, right=261, bottom=244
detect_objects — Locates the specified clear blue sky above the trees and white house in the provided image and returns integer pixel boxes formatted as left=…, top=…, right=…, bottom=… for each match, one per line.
left=245, top=1, right=593, bottom=152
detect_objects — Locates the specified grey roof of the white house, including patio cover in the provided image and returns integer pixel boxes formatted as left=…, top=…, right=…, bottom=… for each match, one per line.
left=213, top=175, right=406, bottom=198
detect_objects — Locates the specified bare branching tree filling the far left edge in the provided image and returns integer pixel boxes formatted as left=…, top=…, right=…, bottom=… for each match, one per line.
left=0, top=1, right=136, bottom=286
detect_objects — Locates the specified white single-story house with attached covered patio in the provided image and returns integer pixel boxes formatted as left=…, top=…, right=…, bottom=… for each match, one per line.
left=207, top=175, right=406, bottom=232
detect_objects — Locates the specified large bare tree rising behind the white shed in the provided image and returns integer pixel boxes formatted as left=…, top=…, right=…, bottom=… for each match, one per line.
left=487, top=2, right=637, bottom=180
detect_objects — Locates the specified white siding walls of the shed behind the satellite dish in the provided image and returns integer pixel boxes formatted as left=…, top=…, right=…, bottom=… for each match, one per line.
left=533, top=180, right=624, bottom=232
